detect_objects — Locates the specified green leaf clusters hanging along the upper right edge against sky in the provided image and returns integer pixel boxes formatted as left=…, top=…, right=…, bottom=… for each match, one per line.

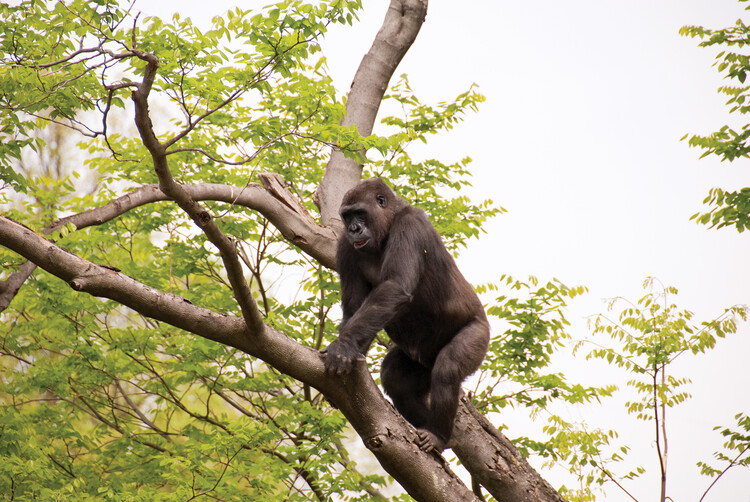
left=680, top=0, right=750, bottom=232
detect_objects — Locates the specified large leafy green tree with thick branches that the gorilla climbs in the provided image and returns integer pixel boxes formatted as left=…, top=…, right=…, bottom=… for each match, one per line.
left=0, top=0, right=588, bottom=501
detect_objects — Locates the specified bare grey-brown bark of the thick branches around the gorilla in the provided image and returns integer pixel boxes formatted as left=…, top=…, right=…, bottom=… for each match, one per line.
left=0, top=0, right=562, bottom=502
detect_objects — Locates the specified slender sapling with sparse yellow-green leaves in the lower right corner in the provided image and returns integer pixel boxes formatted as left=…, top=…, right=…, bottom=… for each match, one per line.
left=576, top=278, right=749, bottom=502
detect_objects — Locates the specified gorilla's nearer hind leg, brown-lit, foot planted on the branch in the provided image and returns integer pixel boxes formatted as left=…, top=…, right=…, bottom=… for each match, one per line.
left=420, top=319, right=490, bottom=451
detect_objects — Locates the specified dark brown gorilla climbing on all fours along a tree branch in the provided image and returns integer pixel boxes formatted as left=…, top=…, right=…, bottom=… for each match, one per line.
left=324, top=179, right=489, bottom=452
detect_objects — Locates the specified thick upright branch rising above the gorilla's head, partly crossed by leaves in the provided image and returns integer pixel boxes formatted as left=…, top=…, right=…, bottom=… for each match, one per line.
left=316, top=0, right=427, bottom=227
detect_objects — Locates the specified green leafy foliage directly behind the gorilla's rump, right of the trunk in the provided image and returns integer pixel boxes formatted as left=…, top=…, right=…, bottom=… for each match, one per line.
left=475, top=276, right=637, bottom=502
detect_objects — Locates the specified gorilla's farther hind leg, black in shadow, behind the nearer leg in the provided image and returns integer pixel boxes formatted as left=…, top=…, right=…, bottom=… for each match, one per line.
left=380, top=347, right=430, bottom=427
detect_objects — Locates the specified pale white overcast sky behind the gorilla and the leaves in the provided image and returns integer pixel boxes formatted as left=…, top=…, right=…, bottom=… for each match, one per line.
left=141, top=0, right=750, bottom=501
